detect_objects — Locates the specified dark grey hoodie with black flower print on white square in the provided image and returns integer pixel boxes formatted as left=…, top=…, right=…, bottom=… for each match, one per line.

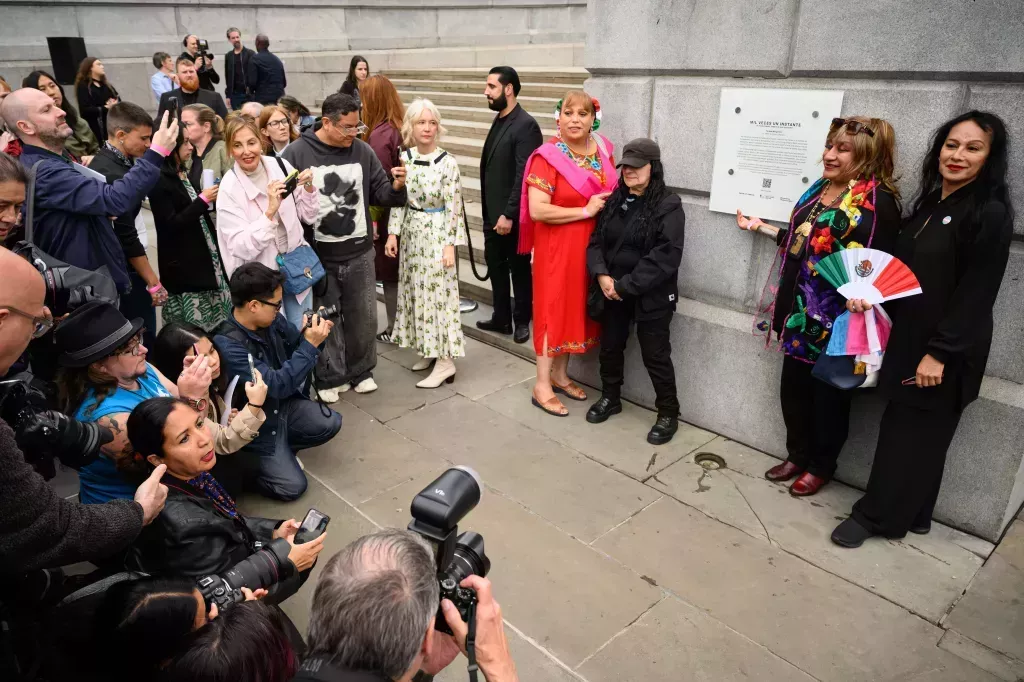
left=282, top=128, right=406, bottom=263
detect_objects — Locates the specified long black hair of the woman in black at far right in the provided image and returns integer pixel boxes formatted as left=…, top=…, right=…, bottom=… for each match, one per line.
left=913, top=110, right=1014, bottom=222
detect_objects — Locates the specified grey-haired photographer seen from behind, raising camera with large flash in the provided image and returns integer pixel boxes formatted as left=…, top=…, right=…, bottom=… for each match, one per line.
left=295, top=467, right=518, bottom=682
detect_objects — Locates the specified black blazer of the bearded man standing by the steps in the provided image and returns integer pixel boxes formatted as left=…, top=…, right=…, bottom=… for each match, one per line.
left=480, top=104, right=544, bottom=229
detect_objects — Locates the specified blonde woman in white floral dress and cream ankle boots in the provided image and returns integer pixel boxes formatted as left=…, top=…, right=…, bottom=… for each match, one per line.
left=385, top=99, right=466, bottom=388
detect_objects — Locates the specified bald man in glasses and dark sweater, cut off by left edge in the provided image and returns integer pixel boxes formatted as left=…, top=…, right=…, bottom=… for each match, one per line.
left=0, top=246, right=167, bottom=576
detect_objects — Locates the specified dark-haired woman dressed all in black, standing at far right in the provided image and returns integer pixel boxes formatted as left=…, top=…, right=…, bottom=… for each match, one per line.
left=831, top=112, right=1014, bottom=547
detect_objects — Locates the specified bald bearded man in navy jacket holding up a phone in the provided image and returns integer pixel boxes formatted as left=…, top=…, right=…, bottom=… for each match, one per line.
left=0, top=88, right=178, bottom=294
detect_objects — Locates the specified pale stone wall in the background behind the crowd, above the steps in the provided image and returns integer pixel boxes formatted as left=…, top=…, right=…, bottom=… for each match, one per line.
left=0, top=0, right=587, bottom=109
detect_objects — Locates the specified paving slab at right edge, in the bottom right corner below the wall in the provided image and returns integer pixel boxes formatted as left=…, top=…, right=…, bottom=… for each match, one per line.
left=943, top=520, right=1024, bottom=660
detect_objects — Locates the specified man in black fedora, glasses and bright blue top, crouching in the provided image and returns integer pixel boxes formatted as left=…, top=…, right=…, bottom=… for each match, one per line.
left=54, top=301, right=212, bottom=504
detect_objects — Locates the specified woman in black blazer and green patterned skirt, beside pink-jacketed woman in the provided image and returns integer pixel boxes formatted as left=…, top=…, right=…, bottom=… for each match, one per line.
left=150, top=131, right=231, bottom=332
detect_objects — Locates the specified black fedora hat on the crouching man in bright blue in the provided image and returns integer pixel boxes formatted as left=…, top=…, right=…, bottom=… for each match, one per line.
left=54, top=301, right=142, bottom=367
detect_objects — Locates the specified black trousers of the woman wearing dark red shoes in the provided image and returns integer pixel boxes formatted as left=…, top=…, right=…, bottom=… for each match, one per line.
left=779, top=355, right=853, bottom=480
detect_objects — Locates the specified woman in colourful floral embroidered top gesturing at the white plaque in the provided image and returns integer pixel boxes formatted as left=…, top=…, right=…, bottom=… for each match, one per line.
left=736, top=116, right=900, bottom=497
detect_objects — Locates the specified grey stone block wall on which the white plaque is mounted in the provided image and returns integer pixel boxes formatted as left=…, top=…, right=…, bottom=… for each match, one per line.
left=575, top=0, right=1024, bottom=540
